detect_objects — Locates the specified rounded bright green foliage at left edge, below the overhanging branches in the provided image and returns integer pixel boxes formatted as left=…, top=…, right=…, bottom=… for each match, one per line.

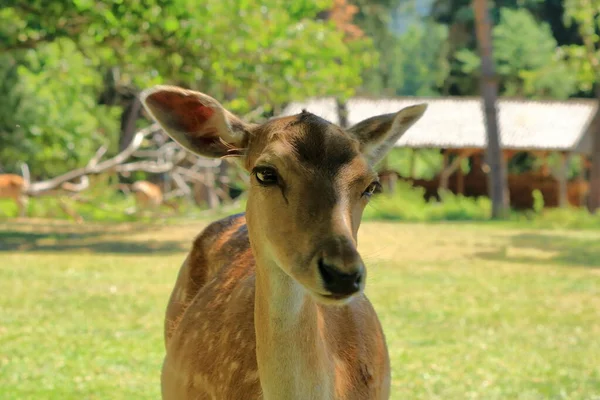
left=0, top=39, right=118, bottom=177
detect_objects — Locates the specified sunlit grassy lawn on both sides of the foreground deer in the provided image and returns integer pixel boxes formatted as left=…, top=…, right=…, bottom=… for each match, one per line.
left=0, top=217, right=600, bottom=400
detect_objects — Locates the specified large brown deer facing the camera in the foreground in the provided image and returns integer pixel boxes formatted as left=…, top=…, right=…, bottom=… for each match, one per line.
left=140, top=85, right=427, bottom=400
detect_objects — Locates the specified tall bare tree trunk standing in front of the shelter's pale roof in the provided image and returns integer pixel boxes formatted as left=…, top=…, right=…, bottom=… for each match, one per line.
left=472, top=0, right=509, bottom=219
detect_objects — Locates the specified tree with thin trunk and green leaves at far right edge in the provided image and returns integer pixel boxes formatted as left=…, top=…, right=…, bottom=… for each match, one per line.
left=565, top=0, right=600, bottom=213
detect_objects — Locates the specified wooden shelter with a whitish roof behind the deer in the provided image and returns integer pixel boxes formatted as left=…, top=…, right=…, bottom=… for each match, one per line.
left=283, top=97, right=596, bottom=208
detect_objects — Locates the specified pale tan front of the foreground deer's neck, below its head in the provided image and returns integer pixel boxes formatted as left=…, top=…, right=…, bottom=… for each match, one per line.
left=254, top=253, right=334, bottom=400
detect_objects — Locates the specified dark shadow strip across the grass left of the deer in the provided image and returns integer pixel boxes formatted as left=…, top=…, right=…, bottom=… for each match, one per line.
left=0, top=226, right=188, bottom=254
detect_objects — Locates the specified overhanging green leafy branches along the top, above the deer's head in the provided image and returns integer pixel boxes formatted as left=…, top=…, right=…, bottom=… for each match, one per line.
left=0, top=0, right=374, bottom=108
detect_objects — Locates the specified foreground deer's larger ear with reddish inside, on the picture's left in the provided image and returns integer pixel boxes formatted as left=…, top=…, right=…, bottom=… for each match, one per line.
left=140, top=85, right=251, bottom=158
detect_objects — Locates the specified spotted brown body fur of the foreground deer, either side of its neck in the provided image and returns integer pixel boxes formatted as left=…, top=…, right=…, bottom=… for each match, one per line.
left=163, top=214, right=389, bottom=400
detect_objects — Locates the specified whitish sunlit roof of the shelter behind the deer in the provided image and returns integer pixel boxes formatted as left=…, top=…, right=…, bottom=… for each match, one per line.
left=283, top=97, right=596, bottom=153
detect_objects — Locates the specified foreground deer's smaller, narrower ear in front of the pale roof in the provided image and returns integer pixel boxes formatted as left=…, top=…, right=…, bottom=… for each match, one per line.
left=348, top=104, right=427, bottom=165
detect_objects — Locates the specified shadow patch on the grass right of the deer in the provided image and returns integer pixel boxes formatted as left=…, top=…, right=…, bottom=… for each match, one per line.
left=477, top=233, right=600, bottom=268
